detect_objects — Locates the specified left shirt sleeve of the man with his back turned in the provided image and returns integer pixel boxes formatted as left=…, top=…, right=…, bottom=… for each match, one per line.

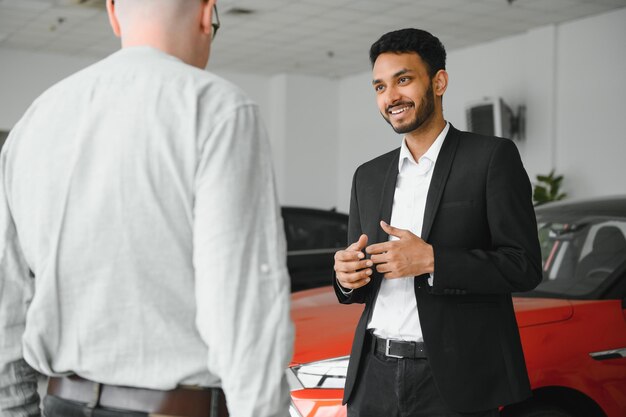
left=0, top=142, right=40, bottom=417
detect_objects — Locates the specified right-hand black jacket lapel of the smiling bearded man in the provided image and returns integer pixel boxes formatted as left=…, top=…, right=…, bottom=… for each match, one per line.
left=421, top=125, right=459, bottom=241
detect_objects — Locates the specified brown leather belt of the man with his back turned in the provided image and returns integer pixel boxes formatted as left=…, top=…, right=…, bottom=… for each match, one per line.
left=48, top=375, right=228, bottom=417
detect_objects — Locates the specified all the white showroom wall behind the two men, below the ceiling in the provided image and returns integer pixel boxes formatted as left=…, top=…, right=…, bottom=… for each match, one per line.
left=0, top=9, right=626, bottom=211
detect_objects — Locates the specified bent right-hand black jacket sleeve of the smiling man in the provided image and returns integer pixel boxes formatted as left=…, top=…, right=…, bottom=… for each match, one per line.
left=433, top=140, right=542, bottom=294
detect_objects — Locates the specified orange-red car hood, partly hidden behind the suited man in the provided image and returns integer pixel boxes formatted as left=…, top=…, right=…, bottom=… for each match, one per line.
left=291, top=287, right=574, bottom=365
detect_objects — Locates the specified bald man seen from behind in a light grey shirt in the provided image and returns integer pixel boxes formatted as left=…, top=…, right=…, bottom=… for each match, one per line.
left=0, top=0, right=293, bottom=417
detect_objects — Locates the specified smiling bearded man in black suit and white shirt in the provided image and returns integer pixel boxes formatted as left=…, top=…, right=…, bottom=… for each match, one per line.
left=334, top=29, right=541, bottom=417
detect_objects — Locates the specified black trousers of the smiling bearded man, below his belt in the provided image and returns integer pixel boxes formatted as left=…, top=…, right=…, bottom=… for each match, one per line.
left=348, top=334, right=499, bottom=417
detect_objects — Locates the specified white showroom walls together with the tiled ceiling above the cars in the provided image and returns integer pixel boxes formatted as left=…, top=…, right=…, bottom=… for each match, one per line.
left=0, top=0, right=626, bottom=212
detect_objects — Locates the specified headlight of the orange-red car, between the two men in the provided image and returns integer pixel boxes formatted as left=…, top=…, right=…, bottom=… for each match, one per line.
left=289, top=356, right=350, bottom=390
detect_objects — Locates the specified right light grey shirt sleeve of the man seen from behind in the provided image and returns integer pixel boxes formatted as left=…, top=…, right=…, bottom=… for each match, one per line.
left=194, top=101, right=293, bottom=417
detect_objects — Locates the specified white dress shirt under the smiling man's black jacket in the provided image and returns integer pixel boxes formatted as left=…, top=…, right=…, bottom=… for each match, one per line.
left=367, top=123, right=450, bottom=341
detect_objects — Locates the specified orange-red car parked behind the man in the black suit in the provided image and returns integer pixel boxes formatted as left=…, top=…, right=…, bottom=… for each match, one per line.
left=288, top=197, right=626, bottom=417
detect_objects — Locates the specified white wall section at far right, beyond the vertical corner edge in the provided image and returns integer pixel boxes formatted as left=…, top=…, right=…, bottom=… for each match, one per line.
left=556, top=9, right=626, bottom=197
